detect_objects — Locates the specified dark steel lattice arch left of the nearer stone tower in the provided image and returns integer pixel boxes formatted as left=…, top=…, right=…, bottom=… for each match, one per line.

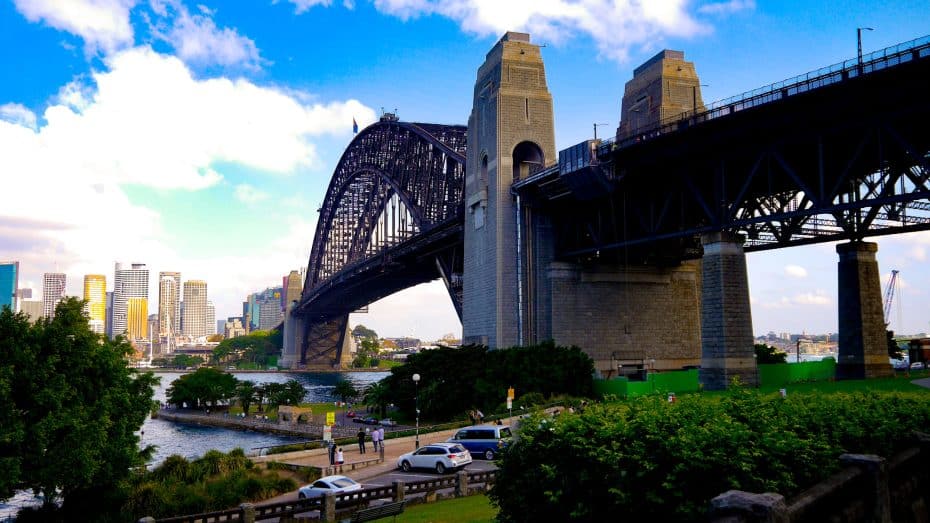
left=299, top=117, right=466, bottom=310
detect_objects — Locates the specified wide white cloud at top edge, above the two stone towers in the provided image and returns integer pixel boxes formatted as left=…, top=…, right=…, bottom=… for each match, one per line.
left=358, top=0, right=720, bottom=61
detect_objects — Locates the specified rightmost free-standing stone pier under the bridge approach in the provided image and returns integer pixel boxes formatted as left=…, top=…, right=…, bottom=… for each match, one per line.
left=836, top=242, right=893, bottom=379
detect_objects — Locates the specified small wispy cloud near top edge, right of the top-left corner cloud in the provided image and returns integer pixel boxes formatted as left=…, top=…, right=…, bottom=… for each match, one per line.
left=151, top=0, right=262, bottom=70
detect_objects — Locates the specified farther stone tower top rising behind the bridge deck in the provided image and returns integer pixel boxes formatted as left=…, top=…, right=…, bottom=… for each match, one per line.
left=617, top=49, right=704, bottom=138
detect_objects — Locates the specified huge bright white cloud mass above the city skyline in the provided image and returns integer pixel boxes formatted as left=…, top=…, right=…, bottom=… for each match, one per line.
left=0, top=48, right=376, bottom=315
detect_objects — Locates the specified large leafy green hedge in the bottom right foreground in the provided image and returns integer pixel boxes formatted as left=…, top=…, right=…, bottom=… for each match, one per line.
left=490, top=388, right=930, bottom=522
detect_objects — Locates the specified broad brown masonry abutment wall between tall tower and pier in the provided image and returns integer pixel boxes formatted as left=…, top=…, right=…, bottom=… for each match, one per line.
left=549, top=262, right=701, bottom=378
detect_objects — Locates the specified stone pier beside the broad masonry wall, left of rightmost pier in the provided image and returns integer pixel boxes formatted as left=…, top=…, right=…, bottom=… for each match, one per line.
left=699, top=232, right=759, bottom=390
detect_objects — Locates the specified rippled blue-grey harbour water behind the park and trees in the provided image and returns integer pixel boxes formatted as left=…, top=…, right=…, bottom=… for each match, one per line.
left=0, top=372, right=390, bottom=522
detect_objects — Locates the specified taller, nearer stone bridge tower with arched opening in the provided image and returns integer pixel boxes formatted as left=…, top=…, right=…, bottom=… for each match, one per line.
left=462, top=32, right=557, bottom=347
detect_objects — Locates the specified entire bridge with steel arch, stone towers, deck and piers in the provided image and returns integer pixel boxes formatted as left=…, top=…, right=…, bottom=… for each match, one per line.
left=282, top=33, right=930, bottom=388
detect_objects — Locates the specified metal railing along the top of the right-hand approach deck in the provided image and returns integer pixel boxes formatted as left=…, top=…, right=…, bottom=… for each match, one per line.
left=598, top=35, right=930, bottom=156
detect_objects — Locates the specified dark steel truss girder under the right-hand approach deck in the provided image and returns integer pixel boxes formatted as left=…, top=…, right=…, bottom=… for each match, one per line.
left=536, top=52, right=930, bottom=264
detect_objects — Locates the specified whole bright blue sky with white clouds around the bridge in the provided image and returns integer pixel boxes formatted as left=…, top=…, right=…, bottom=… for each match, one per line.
left=0, top=0, right=930, bottom=339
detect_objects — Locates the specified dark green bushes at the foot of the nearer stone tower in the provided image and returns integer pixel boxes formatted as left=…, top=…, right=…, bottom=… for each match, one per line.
left=384, top=342, right=594, bottom=418
